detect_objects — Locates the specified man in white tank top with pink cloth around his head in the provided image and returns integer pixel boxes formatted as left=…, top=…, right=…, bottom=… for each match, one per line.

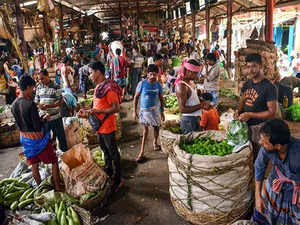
left=175, top=59, right=203, bottom=134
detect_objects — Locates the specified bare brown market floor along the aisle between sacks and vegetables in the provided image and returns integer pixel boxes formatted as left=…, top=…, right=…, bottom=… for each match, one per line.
left=0, top=102, right=190, bottom=225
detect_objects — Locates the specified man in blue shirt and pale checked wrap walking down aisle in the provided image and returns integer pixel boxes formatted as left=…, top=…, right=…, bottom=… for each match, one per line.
left=133, top=64, right=165, bottom=163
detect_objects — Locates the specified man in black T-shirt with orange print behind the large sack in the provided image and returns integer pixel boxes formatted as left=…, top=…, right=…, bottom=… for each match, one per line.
left=235, top=54, right=277, bottom=156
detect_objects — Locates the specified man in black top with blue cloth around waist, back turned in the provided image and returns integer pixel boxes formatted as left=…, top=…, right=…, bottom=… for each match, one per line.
left=11, top=76, right=63, bottom=191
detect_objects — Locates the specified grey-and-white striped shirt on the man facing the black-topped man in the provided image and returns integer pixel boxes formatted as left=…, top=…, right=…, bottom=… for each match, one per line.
left=35, top=81, right=62, bottom=120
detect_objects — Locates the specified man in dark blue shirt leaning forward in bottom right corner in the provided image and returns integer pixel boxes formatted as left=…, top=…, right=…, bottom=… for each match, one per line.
left=255, top=119, right=300, bottom=225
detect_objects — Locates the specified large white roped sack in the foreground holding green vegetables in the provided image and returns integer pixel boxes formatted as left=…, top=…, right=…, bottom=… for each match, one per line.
left=168, top=131, right=253, bottom=225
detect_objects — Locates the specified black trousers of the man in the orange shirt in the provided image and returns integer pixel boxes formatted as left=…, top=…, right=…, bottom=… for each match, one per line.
left=98, top=132, right=121, bottom=184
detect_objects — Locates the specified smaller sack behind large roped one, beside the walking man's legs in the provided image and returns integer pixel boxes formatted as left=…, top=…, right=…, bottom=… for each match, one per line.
left=160, top=120, right=180, bottom=154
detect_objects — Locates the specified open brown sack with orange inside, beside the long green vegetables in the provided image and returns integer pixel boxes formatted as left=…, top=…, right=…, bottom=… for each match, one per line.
left=62, top=144, right=108, bottom=201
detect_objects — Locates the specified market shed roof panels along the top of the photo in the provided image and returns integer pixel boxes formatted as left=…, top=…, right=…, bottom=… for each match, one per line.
left=0, top=0, right=299, bottom=23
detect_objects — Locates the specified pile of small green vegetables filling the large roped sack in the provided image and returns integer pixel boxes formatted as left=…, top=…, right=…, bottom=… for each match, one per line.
left=181, top=138, right=233, bottom=156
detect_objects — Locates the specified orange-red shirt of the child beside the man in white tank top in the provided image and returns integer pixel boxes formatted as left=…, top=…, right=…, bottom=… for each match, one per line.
left=200, top=107, right=220, bottom=130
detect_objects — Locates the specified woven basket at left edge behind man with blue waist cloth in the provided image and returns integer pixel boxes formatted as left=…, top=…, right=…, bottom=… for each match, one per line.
left=0, top=125, right=20, bottom=148
